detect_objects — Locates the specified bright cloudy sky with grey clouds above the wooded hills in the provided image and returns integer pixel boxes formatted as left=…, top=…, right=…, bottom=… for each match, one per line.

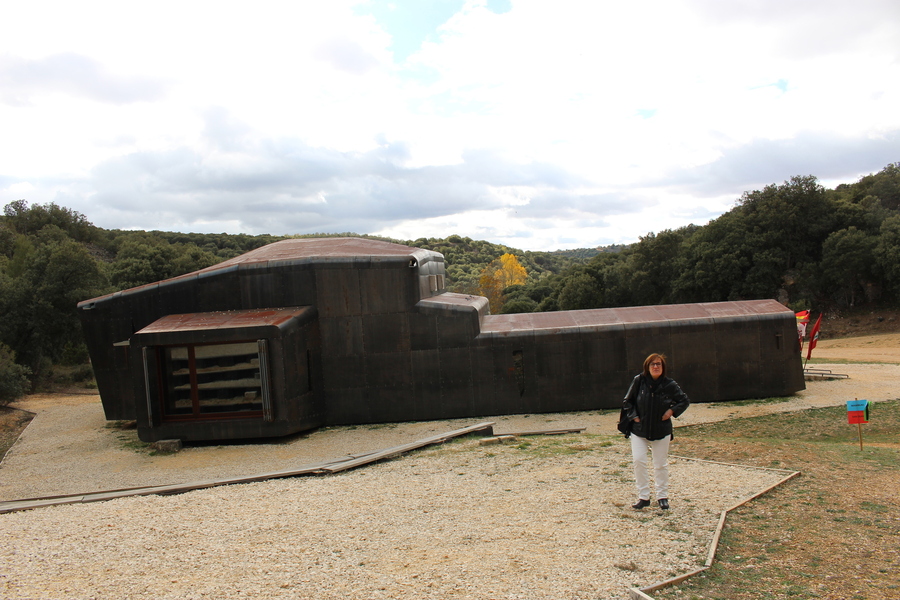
left=0, top=0, right=900, bottom=250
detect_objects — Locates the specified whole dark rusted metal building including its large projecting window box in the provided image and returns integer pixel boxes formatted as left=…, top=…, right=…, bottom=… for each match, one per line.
left=78, top=238, right=804, bottom=441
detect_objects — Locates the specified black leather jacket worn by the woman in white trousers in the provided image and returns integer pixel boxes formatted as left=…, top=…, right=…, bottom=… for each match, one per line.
left=622, top=375, right=691, bottom=440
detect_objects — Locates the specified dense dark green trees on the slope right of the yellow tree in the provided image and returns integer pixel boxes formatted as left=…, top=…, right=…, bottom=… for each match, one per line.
left=503, top=163, right=900, bottom=312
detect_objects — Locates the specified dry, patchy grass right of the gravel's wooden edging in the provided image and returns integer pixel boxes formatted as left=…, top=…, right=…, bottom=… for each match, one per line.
left=653, top=400, right=900, bottom=600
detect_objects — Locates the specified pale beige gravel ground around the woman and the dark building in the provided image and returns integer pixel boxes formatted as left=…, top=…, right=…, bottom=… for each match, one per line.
left=0, top=365, right=900, bottom=600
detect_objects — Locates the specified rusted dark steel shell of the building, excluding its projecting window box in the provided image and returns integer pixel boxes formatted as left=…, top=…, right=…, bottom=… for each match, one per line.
left=79, top=238, right=804, bottom=439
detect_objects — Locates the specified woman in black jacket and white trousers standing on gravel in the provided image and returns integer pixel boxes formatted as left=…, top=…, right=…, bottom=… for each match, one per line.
left=623, top=354, right=690, bottom=510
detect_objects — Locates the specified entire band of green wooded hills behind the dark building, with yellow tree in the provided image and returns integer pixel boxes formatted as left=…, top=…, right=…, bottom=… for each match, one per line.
left=0, top=163, right=900, bottom=401
